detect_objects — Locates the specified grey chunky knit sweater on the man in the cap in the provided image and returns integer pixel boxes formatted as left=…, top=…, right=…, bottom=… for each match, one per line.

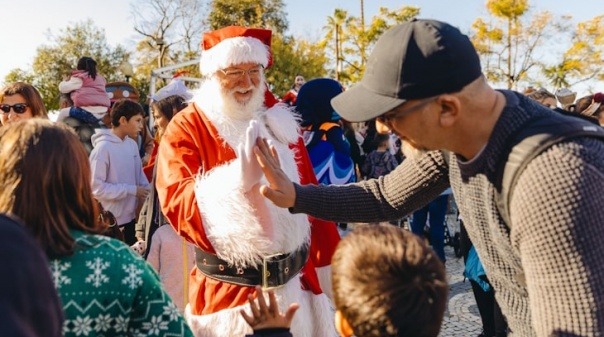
left=291, top=91, right=604, bottom=336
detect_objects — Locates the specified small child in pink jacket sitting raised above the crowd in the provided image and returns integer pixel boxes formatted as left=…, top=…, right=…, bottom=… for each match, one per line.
left=57, top=56, right=110, bottom=126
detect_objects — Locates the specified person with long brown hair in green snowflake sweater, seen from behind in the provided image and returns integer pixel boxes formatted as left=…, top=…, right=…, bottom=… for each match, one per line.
left=0, top=119, right=192, bottom=337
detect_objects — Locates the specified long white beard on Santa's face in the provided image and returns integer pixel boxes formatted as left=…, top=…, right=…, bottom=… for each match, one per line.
left=193, top=77, right=266, bottom=149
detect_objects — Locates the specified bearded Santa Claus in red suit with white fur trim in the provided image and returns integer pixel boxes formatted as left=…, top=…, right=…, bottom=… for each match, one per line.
left=156, top=27, right=339, bottom=337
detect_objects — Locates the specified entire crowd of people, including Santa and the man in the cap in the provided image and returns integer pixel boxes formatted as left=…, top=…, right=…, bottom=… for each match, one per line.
left=0, top=19, right=604, bottom=337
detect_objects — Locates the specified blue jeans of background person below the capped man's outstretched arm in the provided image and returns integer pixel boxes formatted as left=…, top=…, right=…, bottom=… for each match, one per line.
left=411, top=195, right=449, bottom=263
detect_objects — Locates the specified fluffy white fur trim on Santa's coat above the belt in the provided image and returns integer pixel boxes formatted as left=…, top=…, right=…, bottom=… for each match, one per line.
left=195, top=102, right=310, bottom=268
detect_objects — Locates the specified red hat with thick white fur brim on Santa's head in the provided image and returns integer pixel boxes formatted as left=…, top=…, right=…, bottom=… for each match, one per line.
left=200, top=26, right=272, bottom=76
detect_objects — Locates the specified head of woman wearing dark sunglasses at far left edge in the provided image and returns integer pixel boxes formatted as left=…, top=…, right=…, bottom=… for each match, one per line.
left=0, top=82, right=48, bottom=125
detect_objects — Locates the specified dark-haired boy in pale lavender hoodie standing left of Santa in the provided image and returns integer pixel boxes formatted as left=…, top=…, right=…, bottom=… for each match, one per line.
left=90, top=100, right=150, bottom=245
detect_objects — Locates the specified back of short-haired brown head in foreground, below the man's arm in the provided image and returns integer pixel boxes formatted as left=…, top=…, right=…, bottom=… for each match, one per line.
left=331, top=225, right=448, bottom=337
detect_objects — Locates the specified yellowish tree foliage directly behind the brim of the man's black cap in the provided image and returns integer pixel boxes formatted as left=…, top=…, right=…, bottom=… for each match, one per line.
left=323, top=6, right=420, bottom=86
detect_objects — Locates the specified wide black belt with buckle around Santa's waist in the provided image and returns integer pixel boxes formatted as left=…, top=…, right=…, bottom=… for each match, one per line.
left=195, top=245, right=308, bottom=288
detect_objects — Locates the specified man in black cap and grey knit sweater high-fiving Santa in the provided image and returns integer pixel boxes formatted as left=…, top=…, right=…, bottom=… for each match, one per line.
left=255, top=20, right=604, bottom=336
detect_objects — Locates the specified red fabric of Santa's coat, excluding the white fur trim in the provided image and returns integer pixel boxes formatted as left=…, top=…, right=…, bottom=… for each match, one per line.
left=156, top=103, right=339, bottom=315
